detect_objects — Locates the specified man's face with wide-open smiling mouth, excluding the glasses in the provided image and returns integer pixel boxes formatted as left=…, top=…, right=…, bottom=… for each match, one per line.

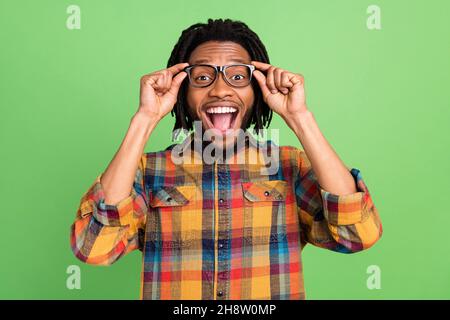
left=187, top=41, right=255, bottom=145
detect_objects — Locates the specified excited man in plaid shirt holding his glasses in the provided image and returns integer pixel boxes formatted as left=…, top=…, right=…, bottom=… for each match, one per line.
left=71, top=19, right=382, bottom=299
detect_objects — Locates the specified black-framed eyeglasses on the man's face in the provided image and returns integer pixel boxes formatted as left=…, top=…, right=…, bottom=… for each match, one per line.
left=184, top=64, right=255, bottom=88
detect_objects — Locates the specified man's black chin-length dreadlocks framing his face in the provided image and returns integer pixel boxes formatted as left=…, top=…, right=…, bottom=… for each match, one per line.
left=167, top=19, right=272, bottom=134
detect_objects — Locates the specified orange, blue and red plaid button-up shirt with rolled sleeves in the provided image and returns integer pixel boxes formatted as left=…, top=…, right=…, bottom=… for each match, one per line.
left=71, top=136, right=382, bottom=300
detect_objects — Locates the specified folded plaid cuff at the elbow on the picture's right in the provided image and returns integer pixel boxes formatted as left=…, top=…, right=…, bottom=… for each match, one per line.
left=319, top=168, right=372, bottom=225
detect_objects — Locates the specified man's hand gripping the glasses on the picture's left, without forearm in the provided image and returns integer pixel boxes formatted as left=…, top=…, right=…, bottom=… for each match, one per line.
left=138, top=63, right=189, bottom=121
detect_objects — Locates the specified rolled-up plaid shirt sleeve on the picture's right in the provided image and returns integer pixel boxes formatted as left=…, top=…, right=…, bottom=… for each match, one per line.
left=295, top=150, right=383, bottom=253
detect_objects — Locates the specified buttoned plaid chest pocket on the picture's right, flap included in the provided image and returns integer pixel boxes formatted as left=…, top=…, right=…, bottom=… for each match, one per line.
left=242, top=180, right=287, bottom=246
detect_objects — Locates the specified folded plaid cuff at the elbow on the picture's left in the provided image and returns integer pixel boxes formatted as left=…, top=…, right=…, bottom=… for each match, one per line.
left=80, top=174, right=136, bottom=227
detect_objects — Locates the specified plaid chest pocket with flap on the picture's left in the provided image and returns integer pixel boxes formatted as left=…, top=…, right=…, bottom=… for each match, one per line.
left=146, top=186, right=202, bottom=248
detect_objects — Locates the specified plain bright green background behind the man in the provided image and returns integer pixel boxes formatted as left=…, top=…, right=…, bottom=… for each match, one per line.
left=0, top=0, right=450, bottom=299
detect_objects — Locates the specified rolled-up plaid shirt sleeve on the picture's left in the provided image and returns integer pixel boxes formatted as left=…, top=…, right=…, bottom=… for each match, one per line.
left=70, top=155, right=148, bottom=265
